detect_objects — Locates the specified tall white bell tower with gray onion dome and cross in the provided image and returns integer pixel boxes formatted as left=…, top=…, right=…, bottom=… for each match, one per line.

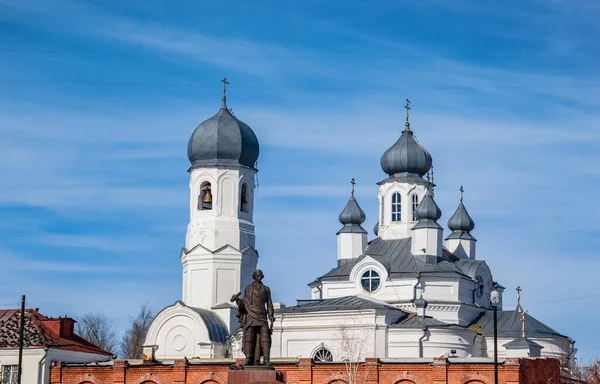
left=181, top=78, right=259, bottom=316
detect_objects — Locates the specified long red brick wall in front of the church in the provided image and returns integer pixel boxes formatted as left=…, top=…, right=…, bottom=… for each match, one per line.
left=50, top=358, right=560, bottom=384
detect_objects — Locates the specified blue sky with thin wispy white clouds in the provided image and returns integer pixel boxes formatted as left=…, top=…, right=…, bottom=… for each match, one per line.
left=0, top=0, right=600, bottom=359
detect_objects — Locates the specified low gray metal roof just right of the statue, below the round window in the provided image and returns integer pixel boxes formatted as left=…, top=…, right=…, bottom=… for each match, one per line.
left=277, top=296, right=407, bottom=317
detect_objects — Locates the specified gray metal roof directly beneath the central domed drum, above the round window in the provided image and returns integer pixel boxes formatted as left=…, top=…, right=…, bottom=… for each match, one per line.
left=311, top=237, right=470, bottom=284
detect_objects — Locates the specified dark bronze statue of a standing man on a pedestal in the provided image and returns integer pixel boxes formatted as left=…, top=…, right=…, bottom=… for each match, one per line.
left=231, top=269, right=275, bottom=366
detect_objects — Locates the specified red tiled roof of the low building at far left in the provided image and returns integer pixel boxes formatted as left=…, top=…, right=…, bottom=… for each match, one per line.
left=0, top=309, right=112, bottom=356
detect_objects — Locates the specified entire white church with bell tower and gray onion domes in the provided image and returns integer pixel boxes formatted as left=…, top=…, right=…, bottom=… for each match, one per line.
left=144, top=88, right=576, bottom=361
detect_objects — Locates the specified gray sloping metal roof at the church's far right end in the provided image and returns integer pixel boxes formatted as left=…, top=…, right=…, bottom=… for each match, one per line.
left=473, top=310, right=568, bottom=339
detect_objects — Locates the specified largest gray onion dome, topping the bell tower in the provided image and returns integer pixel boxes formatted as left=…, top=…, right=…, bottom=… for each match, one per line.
left=188, top=98, right=259, bottom=168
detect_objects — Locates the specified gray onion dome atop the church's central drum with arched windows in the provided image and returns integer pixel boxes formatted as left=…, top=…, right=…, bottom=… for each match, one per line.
left=381, top=126, right=432, bottom=176
